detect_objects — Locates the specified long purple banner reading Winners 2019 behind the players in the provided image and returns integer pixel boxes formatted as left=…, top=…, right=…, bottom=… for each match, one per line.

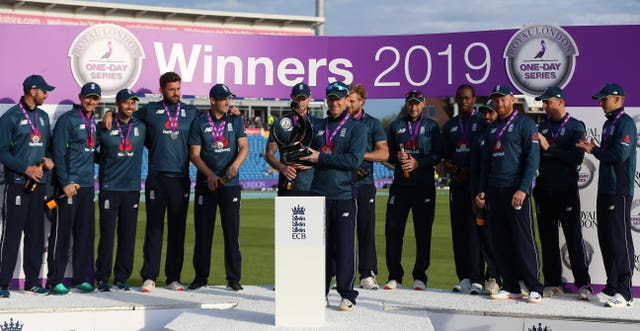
left=0, top=24, right=640, bottom=106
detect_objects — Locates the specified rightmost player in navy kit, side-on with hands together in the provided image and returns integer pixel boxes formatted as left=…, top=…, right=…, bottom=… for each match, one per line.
left=577, top=84, right=638, bottom=308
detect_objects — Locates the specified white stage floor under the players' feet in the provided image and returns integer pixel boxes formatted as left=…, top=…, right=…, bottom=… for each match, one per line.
left=0, top=286, right=640, bottom=331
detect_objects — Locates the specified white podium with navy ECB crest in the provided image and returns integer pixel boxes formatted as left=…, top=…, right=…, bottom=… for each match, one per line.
left=275, top=197, right=326, bottom=327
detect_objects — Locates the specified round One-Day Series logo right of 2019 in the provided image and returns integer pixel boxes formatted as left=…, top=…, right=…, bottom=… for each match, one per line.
left=503, top=25, right=579, bottom=95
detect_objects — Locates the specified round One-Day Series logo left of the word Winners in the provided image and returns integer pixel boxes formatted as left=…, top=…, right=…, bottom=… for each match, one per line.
left=69, top=24, right=144, bottom=97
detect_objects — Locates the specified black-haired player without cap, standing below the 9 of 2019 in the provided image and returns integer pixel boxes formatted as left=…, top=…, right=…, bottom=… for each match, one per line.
left=442, top=84, right=484, bottom=294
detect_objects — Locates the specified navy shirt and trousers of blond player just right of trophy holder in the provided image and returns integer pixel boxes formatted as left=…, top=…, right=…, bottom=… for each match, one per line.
left=356, top=110, right=387, bottom=280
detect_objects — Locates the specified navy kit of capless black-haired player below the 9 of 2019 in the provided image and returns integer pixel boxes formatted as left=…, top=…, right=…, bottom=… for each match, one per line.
left=442, top=114, right=483, bottom=284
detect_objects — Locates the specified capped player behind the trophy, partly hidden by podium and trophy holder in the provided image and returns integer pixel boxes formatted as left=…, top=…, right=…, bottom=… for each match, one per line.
left=265, top=83, right=319, bottom=196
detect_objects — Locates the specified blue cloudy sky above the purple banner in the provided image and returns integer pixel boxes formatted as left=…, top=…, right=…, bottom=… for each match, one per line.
left=87, top=0, right=640, bottom=117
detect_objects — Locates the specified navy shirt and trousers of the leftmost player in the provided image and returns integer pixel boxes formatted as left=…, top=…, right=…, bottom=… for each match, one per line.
left=0, top=99, right=51, bottom=289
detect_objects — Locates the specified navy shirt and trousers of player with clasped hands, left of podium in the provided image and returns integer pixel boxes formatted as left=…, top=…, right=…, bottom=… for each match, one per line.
left=189, top=113, right=247, bottom=284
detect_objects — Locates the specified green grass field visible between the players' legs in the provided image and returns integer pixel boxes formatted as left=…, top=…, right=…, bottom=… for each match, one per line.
left=96, top=190, right=458, bottom=289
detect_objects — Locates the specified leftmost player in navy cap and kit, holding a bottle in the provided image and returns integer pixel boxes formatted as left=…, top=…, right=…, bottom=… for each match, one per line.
left=0, top=75, right=55, bottom=297
